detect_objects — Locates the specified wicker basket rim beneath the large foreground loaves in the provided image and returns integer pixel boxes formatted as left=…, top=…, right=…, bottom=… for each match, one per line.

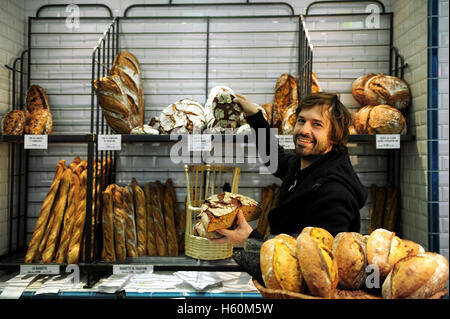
left=253, top=279, right=447, bottom=299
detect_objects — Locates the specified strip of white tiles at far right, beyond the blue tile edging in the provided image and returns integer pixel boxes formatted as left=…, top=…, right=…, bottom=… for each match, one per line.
left=439, top=0, right=450, bottom=259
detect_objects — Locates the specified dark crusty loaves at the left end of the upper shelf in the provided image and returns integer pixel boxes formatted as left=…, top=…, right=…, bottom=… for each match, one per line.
left=2, top=85, right=53, bottom=135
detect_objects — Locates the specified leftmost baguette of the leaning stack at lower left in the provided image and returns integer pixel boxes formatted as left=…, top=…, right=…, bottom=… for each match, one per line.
left=25, top=160, right=66, bottom=263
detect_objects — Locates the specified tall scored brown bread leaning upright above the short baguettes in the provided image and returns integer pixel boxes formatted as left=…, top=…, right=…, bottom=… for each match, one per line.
left=94, top=51, right=144, bottom=134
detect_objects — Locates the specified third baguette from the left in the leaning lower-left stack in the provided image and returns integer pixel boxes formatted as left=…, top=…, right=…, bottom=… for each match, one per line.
left=55, top=168, right=80, bottom=263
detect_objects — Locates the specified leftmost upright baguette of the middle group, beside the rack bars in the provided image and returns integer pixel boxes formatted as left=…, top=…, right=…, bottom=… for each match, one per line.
left=102, top=185, right=116, bottom=262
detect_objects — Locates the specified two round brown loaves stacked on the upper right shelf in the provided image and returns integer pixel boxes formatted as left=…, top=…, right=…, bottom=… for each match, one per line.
left=352, top=73, right=411, bottom=134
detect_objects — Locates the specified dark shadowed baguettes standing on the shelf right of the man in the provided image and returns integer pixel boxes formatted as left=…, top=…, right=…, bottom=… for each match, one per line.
left=369, top=184, right=400, bottom=233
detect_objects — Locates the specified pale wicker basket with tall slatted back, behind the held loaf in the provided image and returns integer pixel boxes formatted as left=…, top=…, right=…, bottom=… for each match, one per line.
left=184, top=165, right=241, bottom=260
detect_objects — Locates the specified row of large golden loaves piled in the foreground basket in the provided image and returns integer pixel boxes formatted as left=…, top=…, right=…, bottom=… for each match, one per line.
left=260, top=227, right=449, bottom=299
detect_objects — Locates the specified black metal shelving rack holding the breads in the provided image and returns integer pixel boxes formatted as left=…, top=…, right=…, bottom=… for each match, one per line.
left=0, top=0, right=413, bottom=290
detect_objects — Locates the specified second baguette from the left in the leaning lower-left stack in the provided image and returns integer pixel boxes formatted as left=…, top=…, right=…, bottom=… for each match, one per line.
left=42, top=168, right=72, bottom=263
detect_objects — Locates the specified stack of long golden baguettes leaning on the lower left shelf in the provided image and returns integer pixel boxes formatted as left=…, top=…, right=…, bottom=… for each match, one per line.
left=25, top=157, right=111, bottom=264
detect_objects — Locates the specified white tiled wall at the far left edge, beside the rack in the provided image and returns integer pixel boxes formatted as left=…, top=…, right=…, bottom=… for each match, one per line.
left=0, top=0, right=25, bottom=255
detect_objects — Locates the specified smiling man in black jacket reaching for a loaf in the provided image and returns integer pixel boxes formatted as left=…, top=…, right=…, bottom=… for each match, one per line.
left=214, top=92, right=368, bottom=244
